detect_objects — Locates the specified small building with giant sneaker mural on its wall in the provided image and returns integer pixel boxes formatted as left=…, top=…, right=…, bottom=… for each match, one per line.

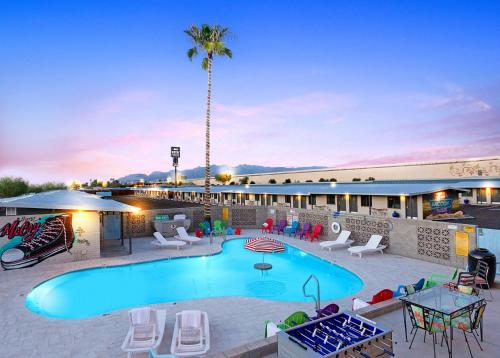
left=0, top=190, right=140, bottom=269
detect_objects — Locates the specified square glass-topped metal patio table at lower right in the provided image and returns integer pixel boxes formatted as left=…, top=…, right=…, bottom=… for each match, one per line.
left=399, top=286, right=484, bottom=357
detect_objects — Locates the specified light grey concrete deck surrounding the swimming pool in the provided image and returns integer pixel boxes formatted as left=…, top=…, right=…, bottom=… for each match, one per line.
left=0, top=230, right=500, bottom=357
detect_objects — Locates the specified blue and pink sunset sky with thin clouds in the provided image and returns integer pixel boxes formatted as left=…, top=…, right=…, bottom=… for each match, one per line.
left=0, top=0, right=500, bottom=183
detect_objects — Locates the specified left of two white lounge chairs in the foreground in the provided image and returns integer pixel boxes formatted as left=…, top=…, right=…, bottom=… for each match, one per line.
left=122, top=307, right=167, bottom=358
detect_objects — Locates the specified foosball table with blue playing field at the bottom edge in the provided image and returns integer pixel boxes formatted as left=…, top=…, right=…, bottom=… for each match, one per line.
left=277, top=311, right=394, bottom=358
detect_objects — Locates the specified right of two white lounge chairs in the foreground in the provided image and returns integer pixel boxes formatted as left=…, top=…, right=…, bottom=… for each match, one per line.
left=170, top=311, right=210, bottom=357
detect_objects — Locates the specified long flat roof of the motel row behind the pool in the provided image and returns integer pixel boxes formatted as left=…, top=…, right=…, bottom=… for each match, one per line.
left=135, top=177, right=500, bottom=196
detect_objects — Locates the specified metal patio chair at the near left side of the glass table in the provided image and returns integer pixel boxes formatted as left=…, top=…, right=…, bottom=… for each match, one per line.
left=407, top=304, right=450, bottom=358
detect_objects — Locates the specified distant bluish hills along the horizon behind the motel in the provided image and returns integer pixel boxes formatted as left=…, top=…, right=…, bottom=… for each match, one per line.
left=118, top=164, right=324, bottom=183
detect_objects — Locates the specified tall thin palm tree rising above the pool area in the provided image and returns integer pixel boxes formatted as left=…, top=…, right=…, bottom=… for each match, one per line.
left=184, top=24, right=233, bottom=222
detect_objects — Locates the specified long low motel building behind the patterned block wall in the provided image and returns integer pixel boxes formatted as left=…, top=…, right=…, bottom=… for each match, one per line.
left=134, top=177, right=500, bottom=220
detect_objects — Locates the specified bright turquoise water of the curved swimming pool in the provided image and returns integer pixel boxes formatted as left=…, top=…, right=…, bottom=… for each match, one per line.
left=26, top=239, right=363, bottom=319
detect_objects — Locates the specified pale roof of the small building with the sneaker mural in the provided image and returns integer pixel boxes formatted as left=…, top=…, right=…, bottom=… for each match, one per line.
left=0, top=190, right=140, bottom=212
